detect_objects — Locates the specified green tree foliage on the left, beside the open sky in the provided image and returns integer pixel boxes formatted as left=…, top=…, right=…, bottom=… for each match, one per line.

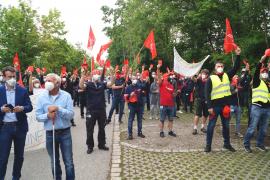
left=0, top=1, right=85, bottom=72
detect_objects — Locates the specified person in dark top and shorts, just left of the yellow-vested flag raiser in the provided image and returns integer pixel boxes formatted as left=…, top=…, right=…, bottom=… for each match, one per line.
left=192, top=69, right=209, bottom=135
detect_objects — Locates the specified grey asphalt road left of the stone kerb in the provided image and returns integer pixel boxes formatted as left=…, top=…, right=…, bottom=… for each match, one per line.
left=6, top=106, right=113, bottom=180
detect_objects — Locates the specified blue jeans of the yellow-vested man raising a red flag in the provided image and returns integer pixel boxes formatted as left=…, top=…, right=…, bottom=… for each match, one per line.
left=206, top=107, right=230, bottom=146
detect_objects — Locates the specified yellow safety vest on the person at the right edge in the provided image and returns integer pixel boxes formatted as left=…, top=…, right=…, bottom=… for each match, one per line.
left=252, top=80, right=270, bottom=103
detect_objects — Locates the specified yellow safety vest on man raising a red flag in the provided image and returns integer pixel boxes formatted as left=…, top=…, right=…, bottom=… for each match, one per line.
left=210, top=73, right=232, bottom=100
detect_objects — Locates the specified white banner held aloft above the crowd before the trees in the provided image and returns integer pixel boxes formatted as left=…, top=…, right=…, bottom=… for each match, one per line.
left=173, top=48, right=210, bottom=77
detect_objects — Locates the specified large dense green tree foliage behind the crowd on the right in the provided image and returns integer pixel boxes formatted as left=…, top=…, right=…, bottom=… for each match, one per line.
left=102, top=0, right=270, bottom=71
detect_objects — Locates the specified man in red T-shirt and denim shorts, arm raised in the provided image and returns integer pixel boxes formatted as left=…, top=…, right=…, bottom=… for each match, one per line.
left=157, top=65, right=176, bottom=137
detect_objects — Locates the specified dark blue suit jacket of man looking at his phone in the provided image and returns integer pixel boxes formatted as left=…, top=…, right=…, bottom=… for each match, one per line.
left=0, top=84, right=33, bottom=132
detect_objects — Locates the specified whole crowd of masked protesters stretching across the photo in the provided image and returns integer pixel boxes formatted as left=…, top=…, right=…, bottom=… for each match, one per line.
left=0, top=47, right=270, bottom=180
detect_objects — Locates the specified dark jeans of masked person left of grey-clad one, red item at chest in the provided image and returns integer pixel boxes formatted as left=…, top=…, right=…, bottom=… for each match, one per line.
left=128, top=104, right=144, bottom=135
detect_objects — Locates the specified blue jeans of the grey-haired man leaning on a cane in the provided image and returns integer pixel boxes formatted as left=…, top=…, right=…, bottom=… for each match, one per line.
left=46, top=129, right=75, bottom=180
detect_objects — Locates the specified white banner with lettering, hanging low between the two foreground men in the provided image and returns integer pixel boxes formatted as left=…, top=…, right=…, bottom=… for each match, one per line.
left=25, top=94, right=45, bottom=151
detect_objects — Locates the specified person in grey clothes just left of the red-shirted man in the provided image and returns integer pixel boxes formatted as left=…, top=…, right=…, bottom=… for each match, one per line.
left=150, top=72, right=160, bottom=120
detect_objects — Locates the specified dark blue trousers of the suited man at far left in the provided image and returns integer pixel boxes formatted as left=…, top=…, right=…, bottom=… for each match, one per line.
left=0, top=125, right=26, bottom=180
